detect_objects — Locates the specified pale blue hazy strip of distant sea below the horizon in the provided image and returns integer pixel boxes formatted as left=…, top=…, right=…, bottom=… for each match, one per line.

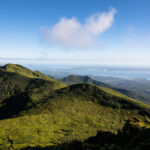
left=24, top=64, right=150, bottom=80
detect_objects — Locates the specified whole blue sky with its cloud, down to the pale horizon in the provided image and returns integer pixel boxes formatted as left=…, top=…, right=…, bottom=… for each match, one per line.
left=0, top=0, right=150, bottom=66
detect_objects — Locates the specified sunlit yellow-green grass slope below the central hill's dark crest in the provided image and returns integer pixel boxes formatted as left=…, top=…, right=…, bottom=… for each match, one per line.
left=0, top=100, right=145, bottom=149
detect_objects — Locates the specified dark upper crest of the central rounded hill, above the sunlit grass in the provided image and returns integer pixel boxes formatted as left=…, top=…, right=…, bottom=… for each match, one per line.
left=22, top=83, right=150, bottom=115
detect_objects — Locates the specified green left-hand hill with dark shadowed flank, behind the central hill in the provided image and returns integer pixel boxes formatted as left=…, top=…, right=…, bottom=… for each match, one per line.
left=0, top=64, right=66, bottom=119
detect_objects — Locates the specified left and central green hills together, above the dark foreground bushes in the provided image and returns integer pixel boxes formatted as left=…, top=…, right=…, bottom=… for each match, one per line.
left=0, top=64, right=150, bottom=150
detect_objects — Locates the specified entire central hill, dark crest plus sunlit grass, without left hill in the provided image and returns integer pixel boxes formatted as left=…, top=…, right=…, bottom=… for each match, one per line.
left=0, top=84, right=150, bottom=149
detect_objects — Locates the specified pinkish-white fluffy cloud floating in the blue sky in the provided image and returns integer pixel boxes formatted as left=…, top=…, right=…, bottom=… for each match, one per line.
left=43, top=8, right=116, bottom=48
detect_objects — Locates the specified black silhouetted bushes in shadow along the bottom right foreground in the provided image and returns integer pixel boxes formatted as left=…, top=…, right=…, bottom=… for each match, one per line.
left=21, top=118, right=150, bottom=150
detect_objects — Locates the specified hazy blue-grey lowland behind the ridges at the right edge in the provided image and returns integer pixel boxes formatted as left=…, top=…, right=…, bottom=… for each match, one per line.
left=91, top=76, right=150, bottom=104
